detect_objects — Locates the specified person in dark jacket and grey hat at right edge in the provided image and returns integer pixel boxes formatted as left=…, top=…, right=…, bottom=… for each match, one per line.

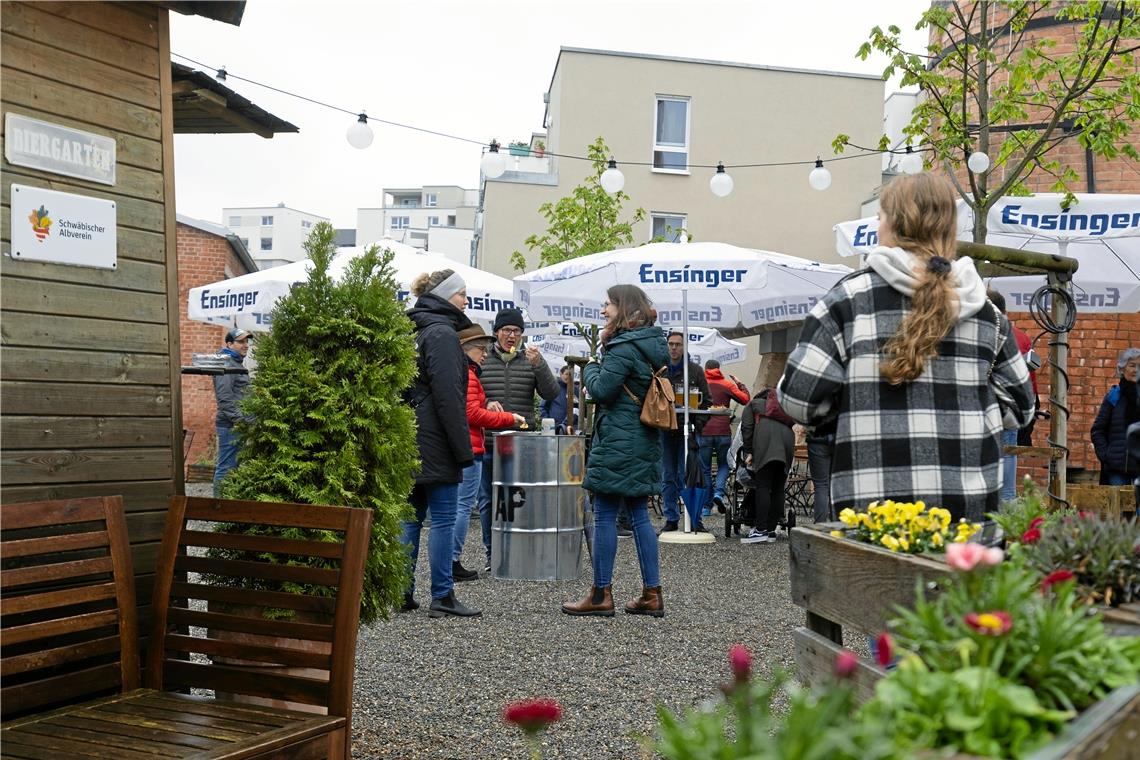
left=1092, top=348, right=1140, bottom=485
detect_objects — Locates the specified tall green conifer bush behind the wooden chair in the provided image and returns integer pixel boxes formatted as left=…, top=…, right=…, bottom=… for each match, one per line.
left=222, top=222, right=418, bottom=623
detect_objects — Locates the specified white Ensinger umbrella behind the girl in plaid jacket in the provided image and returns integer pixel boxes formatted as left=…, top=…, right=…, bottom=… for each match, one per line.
left=834, top=194, right=1140, bottom=312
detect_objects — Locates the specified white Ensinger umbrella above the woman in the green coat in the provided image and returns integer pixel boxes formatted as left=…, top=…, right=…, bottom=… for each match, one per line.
left=514, top=243, right=852, bottom=536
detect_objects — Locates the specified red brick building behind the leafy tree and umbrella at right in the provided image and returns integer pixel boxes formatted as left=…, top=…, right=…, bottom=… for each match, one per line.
left=925, top=2, right=1140, bottom=484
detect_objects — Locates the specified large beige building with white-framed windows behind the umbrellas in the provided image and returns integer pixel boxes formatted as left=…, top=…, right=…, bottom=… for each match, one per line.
left=477, top=48, right=884, bottom=277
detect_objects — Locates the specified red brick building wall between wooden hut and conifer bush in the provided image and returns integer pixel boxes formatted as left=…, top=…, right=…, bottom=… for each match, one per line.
left=178, top=222, right=254, bottom=464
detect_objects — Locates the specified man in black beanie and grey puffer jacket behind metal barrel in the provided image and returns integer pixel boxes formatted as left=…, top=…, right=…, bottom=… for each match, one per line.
left=479, top=308, right=559, bottom=571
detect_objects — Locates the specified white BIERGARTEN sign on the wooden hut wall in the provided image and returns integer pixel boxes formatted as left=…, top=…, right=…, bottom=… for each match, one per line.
left=3, top=112, right=116, bottom=185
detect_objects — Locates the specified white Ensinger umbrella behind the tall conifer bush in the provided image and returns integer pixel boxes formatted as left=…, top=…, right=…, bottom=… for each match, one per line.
left=188, top=238, right=514, bottom=332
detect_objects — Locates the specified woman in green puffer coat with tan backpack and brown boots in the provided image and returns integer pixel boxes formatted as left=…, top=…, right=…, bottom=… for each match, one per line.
left=562, top=285, right=669, bottom=618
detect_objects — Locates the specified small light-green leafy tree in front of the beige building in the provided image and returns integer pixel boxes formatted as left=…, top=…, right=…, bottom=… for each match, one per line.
left=511, top=137, right=645, bottom=271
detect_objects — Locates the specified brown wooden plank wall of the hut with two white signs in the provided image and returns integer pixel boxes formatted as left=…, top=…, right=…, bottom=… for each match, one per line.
left=0, top=2, right=182, bottom=606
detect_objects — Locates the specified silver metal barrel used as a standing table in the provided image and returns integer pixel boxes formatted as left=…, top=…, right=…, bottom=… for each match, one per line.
left=491, top=432, right=587, bottom=581
